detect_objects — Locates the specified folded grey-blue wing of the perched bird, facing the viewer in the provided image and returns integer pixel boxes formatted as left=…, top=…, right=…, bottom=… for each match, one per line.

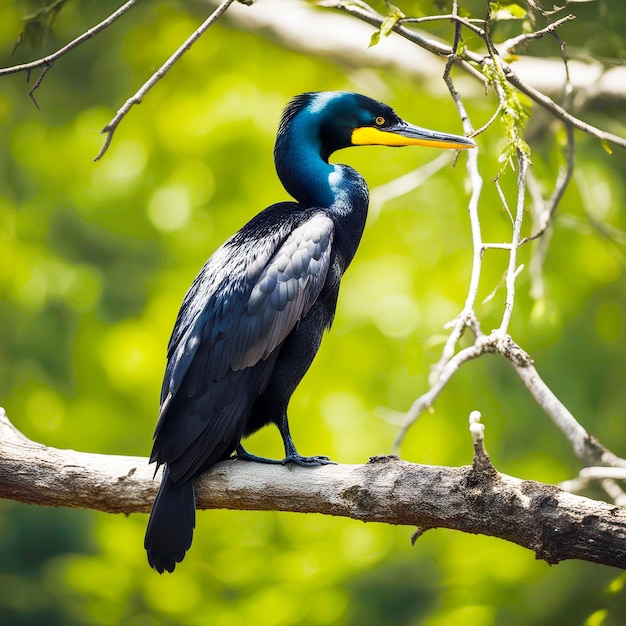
left=157, top=212, right=334, bottom=420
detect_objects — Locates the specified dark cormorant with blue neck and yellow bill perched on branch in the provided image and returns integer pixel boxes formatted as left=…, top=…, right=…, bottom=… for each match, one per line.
left=144, top=91, right=475, bottom=574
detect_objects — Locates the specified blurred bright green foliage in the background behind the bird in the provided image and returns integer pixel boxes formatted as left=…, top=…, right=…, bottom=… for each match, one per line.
left=0, top=0, right=626, bottom=626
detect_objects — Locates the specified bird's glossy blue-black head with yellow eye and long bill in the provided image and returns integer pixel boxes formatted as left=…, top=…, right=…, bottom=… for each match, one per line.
left=278, top=91, right=476, bottom=161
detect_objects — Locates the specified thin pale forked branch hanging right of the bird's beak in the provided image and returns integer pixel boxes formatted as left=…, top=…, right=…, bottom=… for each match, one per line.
left=386, top=17, right=626, bottom=502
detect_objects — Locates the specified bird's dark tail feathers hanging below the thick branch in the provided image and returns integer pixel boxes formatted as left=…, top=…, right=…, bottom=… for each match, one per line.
left=143, top=468, right=196, bottom=574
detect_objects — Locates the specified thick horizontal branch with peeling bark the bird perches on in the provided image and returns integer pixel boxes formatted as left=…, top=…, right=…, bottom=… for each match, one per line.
left=0, top=410, right=626, bottom=568
